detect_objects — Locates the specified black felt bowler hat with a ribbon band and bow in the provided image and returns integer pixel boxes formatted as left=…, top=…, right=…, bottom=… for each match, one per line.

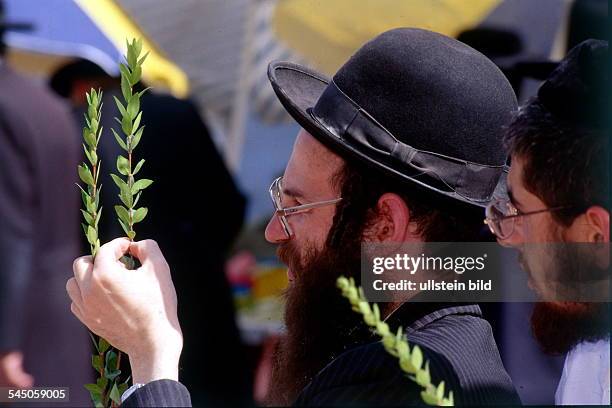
left=268, top=28, right=517, bottom=207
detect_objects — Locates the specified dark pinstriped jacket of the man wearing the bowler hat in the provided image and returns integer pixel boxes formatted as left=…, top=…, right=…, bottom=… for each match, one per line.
left=123, top=303, right=521, bottom=407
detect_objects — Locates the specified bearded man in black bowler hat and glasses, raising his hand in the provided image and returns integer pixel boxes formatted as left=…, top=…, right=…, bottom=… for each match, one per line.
left=67, top=28, right=520, bottom=406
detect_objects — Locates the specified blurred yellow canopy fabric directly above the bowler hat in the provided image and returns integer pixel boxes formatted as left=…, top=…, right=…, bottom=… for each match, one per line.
left=272, top=0, right=502, bottom=75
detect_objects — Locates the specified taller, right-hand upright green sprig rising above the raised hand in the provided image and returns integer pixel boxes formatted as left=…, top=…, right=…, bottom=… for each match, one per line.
left=111, top=39, right=153, bottom=252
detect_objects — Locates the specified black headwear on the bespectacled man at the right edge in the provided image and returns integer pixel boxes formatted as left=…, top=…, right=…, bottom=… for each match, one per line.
left=538, top=39, right=612, bottom=129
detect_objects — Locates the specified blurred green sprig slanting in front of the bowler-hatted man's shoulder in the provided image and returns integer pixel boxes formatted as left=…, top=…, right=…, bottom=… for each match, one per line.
left=336, top=276, right=454, bottom=406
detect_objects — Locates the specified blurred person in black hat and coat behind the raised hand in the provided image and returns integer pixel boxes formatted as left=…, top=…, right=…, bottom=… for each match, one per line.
left=50, top=60, right=252, bottom=406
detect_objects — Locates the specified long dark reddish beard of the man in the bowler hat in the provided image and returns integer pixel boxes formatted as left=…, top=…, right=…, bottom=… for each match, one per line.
left=267, top=240, right=370, bottom=405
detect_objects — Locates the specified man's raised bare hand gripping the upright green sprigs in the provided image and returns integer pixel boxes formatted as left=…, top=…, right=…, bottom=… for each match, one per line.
left=66, top=238, right=183, bottom=383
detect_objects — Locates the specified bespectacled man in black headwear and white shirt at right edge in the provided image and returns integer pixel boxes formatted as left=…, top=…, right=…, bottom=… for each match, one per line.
left=487, top=40, right=611, bottom=405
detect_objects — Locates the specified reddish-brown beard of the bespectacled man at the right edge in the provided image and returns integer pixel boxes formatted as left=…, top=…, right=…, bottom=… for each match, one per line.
left=519, top=225, right=610, bottom=355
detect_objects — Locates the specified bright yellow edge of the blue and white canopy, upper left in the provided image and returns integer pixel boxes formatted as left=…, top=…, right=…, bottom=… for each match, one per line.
left=75, top=0, right=189, bottom=98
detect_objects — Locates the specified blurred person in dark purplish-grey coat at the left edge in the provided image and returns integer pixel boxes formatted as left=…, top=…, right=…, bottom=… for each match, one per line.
left=0, top=1, right=93, bottom=405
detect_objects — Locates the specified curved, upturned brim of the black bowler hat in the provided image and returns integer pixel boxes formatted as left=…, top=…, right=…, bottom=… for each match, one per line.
left=268, top=61, right=487, bottom=208
